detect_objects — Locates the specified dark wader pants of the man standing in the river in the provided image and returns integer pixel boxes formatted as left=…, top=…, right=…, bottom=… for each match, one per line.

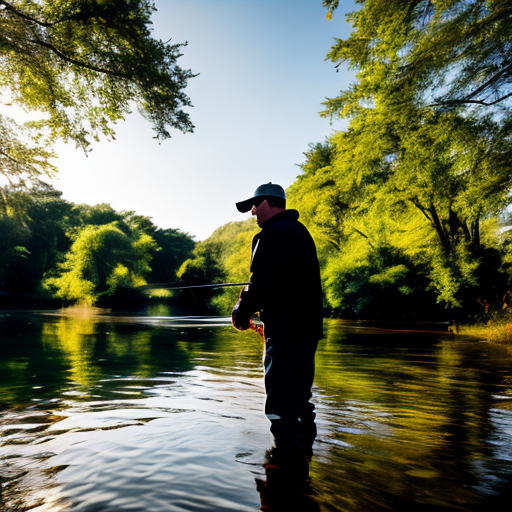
left=264, top=338, right=318, bottom=450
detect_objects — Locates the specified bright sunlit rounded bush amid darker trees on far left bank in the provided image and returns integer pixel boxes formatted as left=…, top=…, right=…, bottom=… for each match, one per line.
left=44, top=223, right=157, bottom=305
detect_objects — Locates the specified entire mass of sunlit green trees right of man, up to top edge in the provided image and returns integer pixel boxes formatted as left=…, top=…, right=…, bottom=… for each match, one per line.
left=287, top=0, right=512, bottom=318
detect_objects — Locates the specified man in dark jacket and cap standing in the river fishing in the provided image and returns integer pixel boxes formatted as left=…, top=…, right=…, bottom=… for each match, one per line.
left=233, top=183, right=323, bottom=474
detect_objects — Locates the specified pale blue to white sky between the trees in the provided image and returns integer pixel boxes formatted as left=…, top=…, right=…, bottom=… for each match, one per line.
left=55, top=0, right=355, bottom=240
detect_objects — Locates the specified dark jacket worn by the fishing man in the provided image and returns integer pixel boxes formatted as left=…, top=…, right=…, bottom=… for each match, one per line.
left=237, top=210, right=323, bottom=341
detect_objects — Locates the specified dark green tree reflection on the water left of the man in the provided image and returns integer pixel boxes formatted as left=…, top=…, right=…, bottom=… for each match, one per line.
left=0, top=314, right=262, bottom=403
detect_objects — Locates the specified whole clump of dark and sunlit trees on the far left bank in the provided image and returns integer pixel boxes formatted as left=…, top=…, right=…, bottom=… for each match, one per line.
left=0, top=182, right=195, bottom=305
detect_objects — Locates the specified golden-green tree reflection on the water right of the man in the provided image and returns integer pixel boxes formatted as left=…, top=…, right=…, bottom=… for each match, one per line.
left=311, top=321, right=504, bottom=510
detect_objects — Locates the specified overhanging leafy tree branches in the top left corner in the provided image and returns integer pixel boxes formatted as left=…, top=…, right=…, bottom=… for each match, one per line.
left=0, top=0, right=194, bottom=202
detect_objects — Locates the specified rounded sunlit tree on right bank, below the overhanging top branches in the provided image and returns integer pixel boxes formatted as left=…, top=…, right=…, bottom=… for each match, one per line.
left=287, top=116, right=510, bottom=318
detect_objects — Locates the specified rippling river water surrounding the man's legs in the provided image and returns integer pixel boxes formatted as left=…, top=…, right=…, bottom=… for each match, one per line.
left=0, top=312, right=512, bottom=512
